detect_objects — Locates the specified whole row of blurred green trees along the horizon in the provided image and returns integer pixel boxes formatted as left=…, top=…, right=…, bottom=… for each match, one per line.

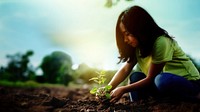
left=0, top=50, right=115, bottom=85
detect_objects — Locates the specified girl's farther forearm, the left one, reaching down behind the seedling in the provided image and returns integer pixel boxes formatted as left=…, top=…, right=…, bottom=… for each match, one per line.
left=108, top=62, right=135, bottom=90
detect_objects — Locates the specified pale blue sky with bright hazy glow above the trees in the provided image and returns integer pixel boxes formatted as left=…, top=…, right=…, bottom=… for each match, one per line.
left=0, top=0, right=200, bottom=69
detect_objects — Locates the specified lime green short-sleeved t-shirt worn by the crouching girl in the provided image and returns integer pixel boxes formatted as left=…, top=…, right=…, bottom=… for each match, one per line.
left=134, top=36, right=200, bottom=80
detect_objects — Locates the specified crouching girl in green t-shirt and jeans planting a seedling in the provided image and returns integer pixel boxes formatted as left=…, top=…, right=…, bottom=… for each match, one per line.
left=109, top=6, right=200, bottom=103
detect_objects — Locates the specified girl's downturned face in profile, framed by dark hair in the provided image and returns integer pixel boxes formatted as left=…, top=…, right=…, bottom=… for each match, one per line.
left=119, top=22, right=138, bottom=47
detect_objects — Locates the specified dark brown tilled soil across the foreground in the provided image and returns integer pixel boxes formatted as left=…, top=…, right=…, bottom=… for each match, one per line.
left=0, top=86, right=200, bottom=112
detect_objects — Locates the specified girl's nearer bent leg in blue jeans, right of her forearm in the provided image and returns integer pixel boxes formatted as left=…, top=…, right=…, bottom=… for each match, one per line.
left=154, top=73, right=198, bottom=96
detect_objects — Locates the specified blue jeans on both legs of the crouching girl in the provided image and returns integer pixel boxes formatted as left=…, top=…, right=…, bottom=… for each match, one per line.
left=129, top=72, right=200, bottom=101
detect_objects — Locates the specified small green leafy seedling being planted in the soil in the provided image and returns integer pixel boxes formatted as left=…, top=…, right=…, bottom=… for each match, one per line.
left=89, top=71, right=112, bottom=100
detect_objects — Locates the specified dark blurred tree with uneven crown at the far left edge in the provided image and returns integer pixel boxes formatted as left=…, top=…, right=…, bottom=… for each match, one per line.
left=0, top=50, right=35, bottom=81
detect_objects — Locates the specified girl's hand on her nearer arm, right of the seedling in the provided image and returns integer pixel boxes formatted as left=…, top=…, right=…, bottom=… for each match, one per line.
left=110, top=86, right=124, bottom=103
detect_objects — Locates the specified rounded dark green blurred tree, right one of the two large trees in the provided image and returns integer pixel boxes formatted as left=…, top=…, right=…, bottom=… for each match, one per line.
left=40, top=51, right=73, bottom=85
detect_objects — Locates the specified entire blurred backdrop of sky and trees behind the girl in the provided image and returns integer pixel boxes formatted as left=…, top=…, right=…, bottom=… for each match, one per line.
left=0, top=0, right=200, bottom=85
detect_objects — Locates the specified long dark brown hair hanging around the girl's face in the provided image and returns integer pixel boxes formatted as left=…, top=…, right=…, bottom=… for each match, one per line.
left=116, top=6, right=172, bottom=62
